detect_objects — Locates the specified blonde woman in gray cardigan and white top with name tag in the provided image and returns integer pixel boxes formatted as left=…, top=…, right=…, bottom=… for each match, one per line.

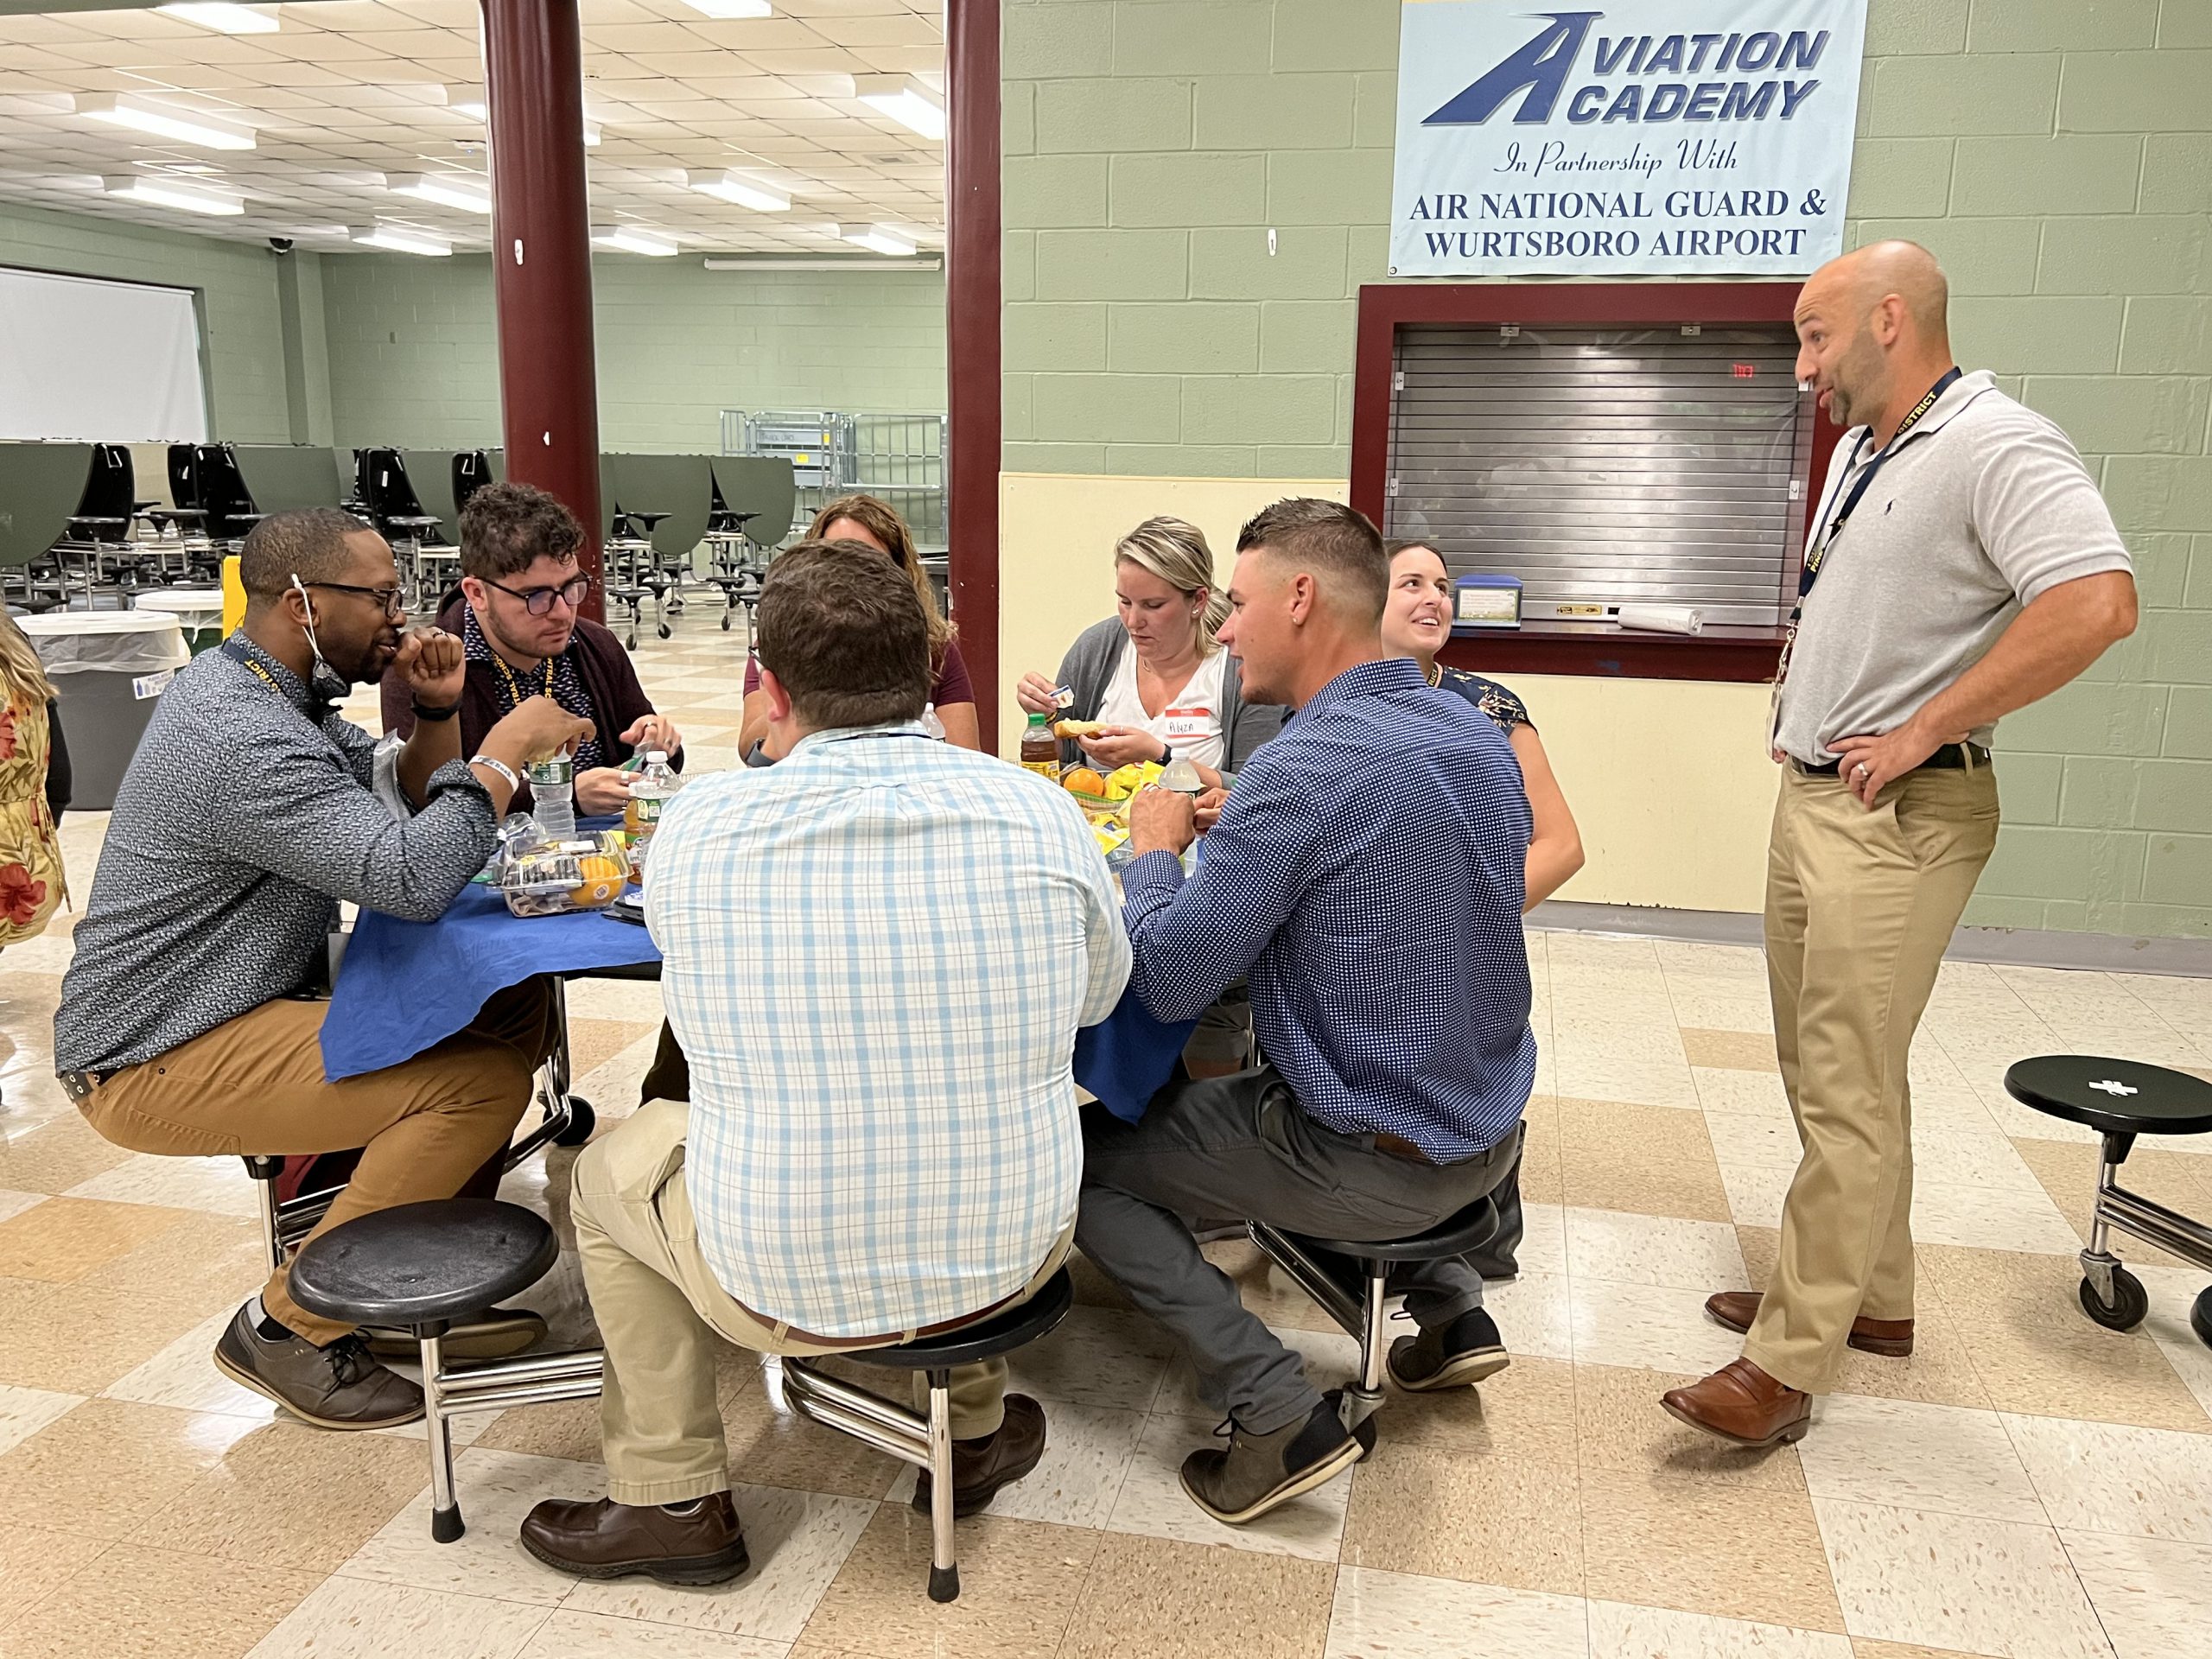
left=1013, top=518, right=1283, bottom=787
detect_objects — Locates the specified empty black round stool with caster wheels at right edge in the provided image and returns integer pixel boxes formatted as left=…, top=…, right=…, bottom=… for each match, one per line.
left=2004, top=1055, right=2212, bottom=1347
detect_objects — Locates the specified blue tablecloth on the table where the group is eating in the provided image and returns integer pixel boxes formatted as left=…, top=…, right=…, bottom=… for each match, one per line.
left=323, top=885, right=1194, bottom=1123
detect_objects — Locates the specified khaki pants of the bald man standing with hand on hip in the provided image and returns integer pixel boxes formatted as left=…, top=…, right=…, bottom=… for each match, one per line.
left=1743, top=763, right=1998, bottom=1394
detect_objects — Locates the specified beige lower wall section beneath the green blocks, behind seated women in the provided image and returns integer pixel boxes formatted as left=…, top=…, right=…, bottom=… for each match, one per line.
left=998, top=474, right=1774, bottom=912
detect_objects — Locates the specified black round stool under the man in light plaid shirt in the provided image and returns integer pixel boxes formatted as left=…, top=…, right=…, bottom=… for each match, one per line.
left=783, top=1268, right=1075, bottom=1601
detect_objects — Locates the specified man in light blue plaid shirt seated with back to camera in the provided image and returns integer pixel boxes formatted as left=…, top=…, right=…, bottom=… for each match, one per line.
left=522, top=544, right=1130, bottom=1584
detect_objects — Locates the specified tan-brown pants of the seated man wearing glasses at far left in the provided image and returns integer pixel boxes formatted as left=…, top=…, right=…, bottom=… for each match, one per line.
left=78, top=980, right=556, bottom=1343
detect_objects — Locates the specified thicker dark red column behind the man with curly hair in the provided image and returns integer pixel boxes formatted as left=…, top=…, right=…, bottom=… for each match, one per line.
left=482, top=0, right=606, bottom=621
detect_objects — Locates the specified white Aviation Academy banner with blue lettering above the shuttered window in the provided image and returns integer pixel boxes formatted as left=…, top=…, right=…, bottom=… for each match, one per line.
left=1389, top=0, right=1867, bottom=276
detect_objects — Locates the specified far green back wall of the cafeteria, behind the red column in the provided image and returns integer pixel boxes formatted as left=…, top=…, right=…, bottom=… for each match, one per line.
left=323, top=254, right=944, bottom=454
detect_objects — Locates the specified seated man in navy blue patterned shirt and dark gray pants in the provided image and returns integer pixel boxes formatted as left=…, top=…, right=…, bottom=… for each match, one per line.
left=1075, top=500, right=1535, bottom=1526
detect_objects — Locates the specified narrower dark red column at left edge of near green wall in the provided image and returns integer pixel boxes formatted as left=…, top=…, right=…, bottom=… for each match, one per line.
left=942, top=0, right=1000, bottom=754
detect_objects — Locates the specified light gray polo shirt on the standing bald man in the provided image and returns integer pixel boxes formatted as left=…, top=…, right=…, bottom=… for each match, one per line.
left=1774, top=370, right=2130, bottom=766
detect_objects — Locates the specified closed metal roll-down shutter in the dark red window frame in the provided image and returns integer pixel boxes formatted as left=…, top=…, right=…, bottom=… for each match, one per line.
left=1385, top=323, right=1814, bottom=626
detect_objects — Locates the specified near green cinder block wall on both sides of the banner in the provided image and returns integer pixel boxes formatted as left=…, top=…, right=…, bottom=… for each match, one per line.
left=1004, top=0, right=2212, bottom=938
